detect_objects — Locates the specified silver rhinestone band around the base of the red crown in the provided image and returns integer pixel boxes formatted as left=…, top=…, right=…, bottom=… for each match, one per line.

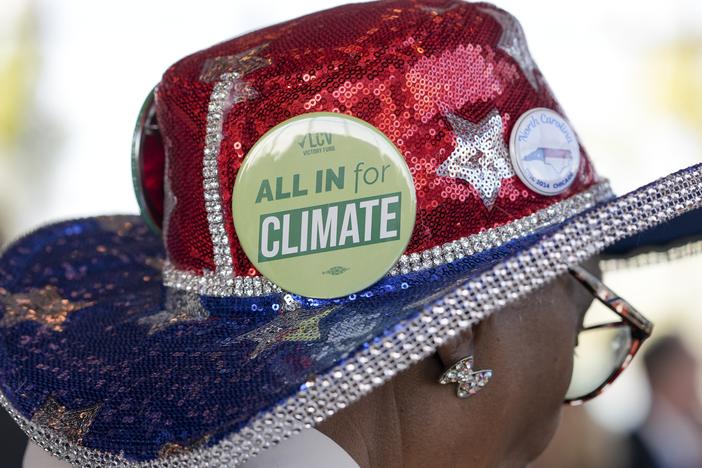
left=163, top=182, right=613, bottom=297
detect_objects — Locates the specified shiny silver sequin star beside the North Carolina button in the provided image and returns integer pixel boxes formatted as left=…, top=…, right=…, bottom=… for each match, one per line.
left=436, top=109, right=514, bottom=210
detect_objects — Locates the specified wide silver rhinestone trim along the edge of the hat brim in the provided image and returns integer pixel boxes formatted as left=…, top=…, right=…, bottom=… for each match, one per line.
left=0, top=165, right=702, bottom=467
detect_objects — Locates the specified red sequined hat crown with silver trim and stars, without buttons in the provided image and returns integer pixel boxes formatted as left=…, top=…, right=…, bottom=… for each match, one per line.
left=135, top=1, right=609, bottom=295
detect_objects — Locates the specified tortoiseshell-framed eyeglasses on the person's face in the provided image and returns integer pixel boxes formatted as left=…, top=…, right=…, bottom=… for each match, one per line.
left=565, top=266, right=653, bottom=406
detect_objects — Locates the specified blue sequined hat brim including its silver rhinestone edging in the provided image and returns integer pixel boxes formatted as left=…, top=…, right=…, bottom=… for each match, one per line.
left=0, top=165, right=702, bottom=466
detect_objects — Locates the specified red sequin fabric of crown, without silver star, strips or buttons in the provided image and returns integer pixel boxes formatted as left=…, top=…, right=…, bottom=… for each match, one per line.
left=147, top=0, right=597, bottom=276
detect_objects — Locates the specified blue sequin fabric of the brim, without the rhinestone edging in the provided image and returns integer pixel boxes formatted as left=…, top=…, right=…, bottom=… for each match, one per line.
left=0, top=216, right=568, bottom=461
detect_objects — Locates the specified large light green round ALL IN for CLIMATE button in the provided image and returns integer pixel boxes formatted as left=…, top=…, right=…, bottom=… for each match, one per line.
left=232, top=112, right=416, bottom=298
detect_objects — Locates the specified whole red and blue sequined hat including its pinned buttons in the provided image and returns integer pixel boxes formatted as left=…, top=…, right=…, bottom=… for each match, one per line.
left=0, top=1, right=702, bottom=466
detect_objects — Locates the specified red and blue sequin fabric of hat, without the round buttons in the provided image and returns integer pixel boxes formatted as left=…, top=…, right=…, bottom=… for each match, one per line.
left=0, top=0, right=702, bottom=467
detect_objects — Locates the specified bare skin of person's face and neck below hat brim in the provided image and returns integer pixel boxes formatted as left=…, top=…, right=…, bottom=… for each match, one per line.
left=318, top=259, right=600, bottom=468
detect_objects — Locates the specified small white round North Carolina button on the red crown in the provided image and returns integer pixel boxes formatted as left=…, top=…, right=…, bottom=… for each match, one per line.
left=509, top=107, right=580, bottom=195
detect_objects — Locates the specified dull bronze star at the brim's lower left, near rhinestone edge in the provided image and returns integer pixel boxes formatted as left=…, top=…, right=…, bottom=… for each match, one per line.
left=32, top=397, right=100, bottom=444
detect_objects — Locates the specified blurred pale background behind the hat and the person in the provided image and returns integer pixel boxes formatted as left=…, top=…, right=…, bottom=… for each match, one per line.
left=0, top=0, right=702, bottom=467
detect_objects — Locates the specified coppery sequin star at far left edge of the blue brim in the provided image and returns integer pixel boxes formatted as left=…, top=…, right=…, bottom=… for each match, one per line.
left=0, top=285, right=95, bottom=332
